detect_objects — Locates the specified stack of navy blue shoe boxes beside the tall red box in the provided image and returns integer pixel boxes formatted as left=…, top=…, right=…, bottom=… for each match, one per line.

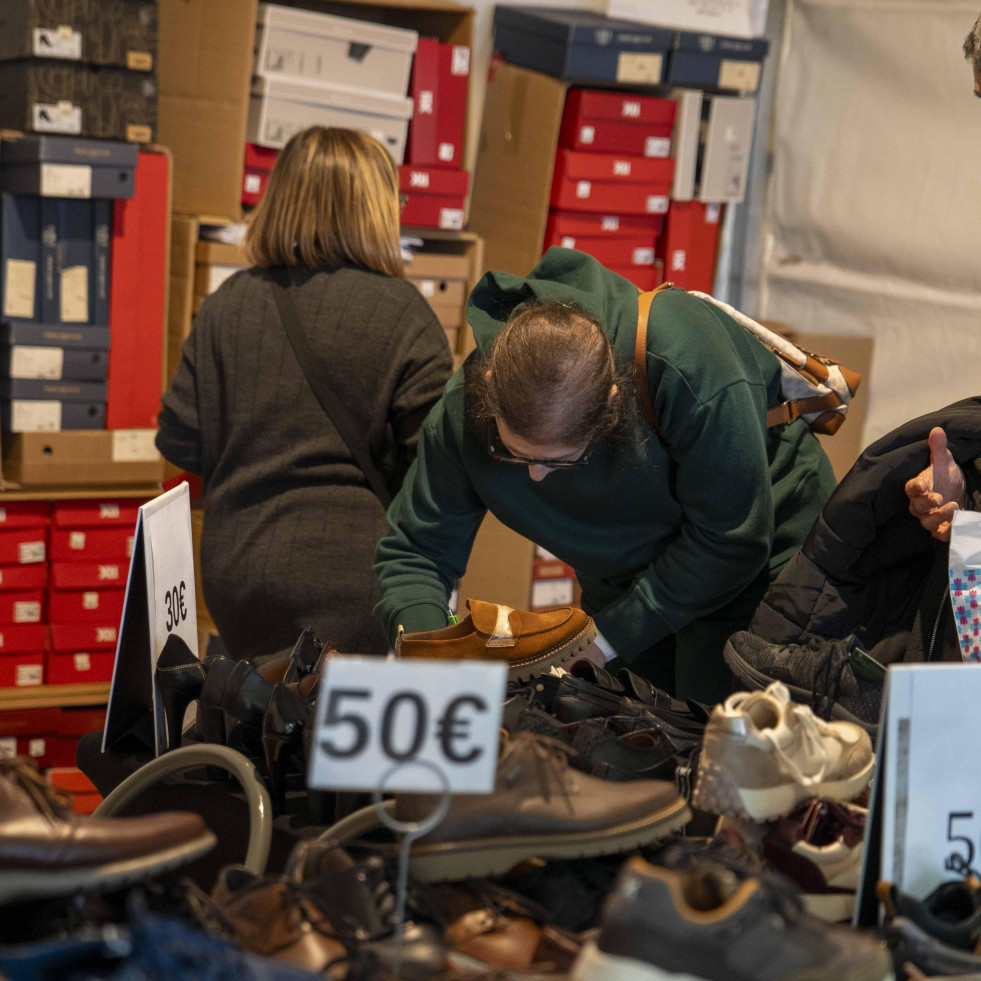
left=0, top=135, right=138, bottom=432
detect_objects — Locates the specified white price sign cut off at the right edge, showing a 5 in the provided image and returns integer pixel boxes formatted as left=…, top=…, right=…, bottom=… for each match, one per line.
left=879, top=663, right=981, bottom=897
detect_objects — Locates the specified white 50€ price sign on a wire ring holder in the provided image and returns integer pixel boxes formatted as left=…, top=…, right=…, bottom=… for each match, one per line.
left=307, top=656, right=507, bottom=794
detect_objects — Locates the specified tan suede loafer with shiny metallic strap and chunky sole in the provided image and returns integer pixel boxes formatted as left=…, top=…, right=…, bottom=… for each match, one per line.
left=395, top=599, right=596, bottom=681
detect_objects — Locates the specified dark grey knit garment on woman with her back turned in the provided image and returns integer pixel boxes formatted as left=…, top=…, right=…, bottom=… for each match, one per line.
left=157, top=267, right=451, bottom=658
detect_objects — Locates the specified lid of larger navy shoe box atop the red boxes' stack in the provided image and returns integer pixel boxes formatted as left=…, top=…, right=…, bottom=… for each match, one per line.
left=494, top=6, right=674, bottom=52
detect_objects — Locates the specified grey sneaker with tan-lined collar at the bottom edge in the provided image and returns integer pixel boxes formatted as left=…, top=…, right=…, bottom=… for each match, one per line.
left=570, top=857, right=894, bottom=981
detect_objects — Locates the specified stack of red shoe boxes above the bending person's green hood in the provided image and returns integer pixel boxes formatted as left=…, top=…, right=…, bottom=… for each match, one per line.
left=544, top=88, right=675, bottom=290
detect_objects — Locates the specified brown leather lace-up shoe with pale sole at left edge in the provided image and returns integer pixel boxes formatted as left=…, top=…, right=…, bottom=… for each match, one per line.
left=0, top=758, right=217, bottom=903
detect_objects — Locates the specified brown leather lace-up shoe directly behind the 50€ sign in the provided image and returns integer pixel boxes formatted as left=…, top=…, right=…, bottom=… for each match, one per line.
left=395, top=732, right=691, bottom=882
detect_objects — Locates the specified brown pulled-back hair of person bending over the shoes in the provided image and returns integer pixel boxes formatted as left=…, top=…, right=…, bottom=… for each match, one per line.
left=475, top=301, right=633, bottom=446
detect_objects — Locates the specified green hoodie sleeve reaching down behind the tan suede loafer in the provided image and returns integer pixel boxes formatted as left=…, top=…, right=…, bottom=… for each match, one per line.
left=375, top=395, right=485, bottom=642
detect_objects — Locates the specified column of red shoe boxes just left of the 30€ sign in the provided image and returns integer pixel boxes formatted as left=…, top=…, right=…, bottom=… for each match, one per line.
left=47, top=499, right=140, bottom=685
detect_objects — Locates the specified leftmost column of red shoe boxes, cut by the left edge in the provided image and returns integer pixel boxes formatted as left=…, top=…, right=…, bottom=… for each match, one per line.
left=0, top=501, right=51, bottom=689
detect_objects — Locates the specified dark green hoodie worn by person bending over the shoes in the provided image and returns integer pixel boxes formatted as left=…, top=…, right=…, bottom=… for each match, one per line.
left=375, top=248, right=835, bottom=660
